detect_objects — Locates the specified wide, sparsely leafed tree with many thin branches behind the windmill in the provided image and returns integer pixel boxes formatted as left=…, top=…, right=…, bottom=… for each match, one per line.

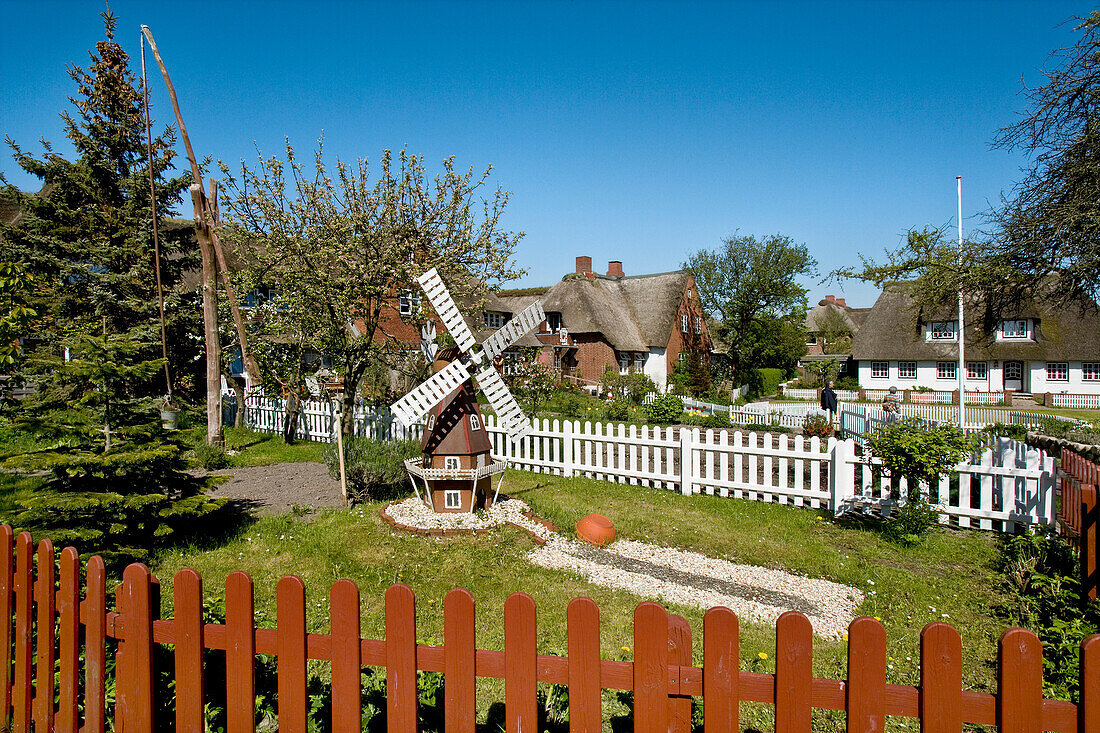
left=221, top=144, right=523, bottom=433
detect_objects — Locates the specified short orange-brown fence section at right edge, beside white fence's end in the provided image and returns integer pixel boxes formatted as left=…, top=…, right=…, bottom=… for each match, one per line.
left=1058, top=448, right=1100, bottom=601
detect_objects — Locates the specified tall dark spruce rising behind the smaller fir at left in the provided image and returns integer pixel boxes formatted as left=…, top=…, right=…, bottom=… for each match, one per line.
left=0, top=13, right=198, bottom=383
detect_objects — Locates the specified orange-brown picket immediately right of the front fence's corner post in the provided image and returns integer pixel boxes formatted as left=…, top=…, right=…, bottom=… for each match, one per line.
left=172, top=568, right=206, bottom=731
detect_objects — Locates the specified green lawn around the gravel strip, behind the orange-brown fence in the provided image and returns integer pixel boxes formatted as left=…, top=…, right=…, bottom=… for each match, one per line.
left=155, top=471, right=1005, bottom=727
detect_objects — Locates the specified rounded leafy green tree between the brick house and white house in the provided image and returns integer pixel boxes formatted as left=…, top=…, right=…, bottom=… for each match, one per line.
left=683, top=234, right=817, bottom=384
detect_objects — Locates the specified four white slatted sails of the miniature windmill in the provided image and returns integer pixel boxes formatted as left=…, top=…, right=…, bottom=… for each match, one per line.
left=391, top=269, right=546, bottom=440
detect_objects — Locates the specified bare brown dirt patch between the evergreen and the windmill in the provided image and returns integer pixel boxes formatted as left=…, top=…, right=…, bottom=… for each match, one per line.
left=202, top=463, right=344, bottom=514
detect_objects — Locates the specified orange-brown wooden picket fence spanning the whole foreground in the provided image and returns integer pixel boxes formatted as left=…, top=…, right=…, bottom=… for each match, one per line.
left=0, top=527, right=1100, bottom=733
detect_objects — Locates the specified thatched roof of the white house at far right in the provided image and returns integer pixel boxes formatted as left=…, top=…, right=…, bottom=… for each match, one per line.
left=851, top=283, right=1100, bottom=361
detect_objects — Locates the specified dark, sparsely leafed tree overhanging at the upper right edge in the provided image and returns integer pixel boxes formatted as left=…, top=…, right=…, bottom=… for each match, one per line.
left=992, top=10, right=1100, bottom=303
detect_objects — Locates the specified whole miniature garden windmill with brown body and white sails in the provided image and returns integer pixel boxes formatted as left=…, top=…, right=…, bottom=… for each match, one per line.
left=391, top=269, right=546, bottom=512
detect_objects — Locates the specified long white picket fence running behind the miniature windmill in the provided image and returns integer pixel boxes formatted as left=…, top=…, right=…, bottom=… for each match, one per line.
left=236, top=396, right=1056, bottom=532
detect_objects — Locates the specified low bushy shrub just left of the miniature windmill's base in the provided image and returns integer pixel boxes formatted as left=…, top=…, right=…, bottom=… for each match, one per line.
left=322, top=437, right=420, bottom=502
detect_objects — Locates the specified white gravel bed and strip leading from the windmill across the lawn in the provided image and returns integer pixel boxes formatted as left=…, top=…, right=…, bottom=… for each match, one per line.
left=385, top=496, right=864, bottom=636
